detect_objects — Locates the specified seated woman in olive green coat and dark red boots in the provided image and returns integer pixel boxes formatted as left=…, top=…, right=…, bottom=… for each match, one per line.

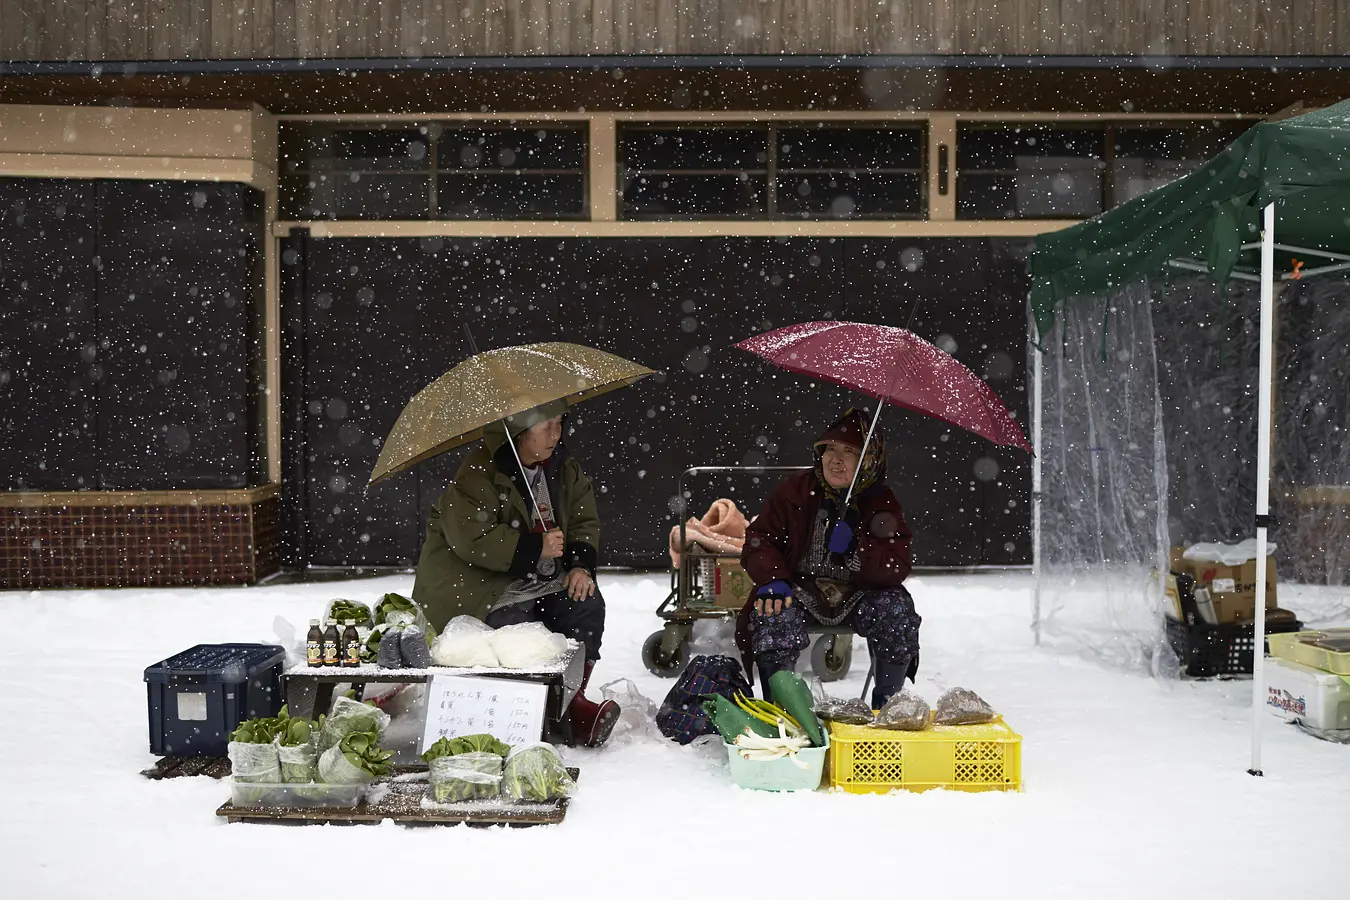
left=413, top=401, right=620, bottom=746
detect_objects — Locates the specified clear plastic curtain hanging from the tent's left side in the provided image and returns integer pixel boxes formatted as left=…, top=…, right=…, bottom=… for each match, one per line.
left=1031, top=283, right=1176, bottom=672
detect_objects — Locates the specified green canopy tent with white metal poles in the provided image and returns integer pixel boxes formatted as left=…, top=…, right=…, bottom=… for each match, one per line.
left=1030, top=101, right=1350, bottom=775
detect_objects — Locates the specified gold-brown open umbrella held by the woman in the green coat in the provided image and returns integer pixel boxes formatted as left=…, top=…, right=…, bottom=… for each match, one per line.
left=370, top=341, right=655, bottom=484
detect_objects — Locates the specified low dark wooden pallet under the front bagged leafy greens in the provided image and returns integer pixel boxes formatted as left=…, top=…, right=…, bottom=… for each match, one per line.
left=216, top=769, right=581, bottom=827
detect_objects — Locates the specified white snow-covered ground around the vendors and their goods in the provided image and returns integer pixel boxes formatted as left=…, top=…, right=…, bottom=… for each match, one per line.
left=0, top=575, right=1350, bottom=900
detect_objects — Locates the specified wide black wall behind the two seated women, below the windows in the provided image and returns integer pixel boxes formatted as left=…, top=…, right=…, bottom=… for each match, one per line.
left=295, top=239, right=1029, bottom=565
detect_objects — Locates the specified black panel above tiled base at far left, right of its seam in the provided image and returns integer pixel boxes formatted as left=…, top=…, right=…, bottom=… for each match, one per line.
left=99, top=181, right=262, bottom=490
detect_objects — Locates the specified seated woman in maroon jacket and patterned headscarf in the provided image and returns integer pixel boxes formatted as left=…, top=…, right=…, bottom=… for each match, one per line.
left=737, top=409, right=921, bottom=708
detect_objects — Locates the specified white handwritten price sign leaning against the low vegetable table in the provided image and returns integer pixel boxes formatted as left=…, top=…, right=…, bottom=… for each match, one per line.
left=421, top=675, right=548, bottom=750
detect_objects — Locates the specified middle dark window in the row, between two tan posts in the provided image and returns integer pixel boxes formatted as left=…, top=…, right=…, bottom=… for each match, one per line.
left=618, top=123, right=926, bottom=220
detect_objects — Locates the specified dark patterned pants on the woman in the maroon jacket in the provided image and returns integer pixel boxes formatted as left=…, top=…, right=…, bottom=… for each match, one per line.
left=751, top=587, right=922, bottom=669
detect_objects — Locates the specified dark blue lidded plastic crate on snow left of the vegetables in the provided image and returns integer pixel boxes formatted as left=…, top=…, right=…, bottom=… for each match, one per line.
left=146, top=644, right=286, bottom=756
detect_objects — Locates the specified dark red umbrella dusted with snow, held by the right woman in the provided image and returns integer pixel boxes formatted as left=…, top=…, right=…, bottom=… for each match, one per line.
left=736, top=321, right=1031, bottom=497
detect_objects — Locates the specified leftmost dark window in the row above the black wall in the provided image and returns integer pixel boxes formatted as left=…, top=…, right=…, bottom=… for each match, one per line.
left=279, top=121, right=589, bottom=220
